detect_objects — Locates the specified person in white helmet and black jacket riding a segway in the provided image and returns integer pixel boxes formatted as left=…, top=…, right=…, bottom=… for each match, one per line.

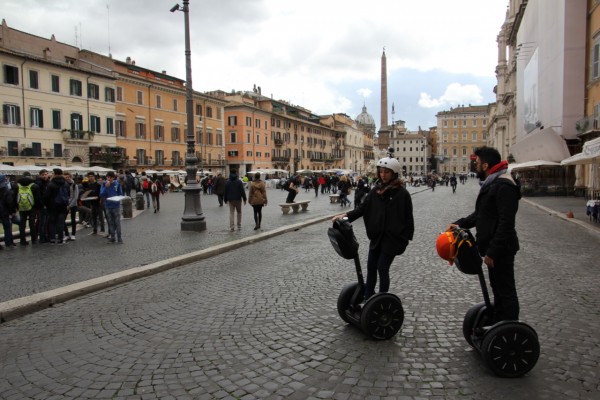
left=333, top=157, right=415, bottom=300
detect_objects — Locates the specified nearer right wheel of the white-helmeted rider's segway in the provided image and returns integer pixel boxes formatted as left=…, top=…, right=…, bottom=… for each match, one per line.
left=360, top=293, right=404, bottom=340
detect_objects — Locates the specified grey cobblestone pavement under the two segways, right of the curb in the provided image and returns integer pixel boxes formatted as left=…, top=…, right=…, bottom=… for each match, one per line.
left=0, top=182, right=600, bottom=399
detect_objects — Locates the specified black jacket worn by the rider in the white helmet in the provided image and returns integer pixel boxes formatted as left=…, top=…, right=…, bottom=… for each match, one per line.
left=347, top=182, right=415, bottom=255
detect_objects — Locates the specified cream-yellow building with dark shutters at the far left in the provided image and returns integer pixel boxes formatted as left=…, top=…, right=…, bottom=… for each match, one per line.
left=0, top=21, right=123, bottom=166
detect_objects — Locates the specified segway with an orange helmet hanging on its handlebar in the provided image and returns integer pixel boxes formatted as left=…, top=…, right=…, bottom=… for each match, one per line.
left=437, top=228, right=540, bottom=378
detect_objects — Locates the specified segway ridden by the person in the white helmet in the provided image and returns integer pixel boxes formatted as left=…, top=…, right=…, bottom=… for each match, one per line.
left=327, top=218, right=404, bottom=340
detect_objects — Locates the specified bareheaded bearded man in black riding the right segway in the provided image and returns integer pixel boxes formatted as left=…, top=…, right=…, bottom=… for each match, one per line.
left=446, top=147, right=521, bottom=323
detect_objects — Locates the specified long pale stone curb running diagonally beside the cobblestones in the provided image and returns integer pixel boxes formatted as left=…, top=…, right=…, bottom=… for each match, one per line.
left=0, top=213, right=332, bottom=323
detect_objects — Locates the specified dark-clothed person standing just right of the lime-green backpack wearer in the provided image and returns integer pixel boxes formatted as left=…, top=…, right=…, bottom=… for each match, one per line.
left=43, top=168, right=69, bottom=244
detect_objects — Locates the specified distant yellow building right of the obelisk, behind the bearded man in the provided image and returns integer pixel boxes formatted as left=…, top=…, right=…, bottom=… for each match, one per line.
left=436, top=105, right=488, bottom=174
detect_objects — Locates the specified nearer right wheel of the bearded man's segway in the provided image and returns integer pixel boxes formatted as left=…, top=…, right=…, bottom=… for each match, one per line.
left=481, top=321, right=540, bottom=378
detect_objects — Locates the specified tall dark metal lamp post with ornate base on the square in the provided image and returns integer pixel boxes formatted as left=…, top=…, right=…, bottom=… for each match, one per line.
left=171, top=0, right=206, bottom=232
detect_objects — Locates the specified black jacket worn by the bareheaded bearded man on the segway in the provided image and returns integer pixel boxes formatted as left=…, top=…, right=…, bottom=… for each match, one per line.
left=455, top=173, right=521, bottom=259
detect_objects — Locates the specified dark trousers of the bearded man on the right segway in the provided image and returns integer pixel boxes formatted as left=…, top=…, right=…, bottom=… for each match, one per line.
left=488, top=254, right=520, bottom=323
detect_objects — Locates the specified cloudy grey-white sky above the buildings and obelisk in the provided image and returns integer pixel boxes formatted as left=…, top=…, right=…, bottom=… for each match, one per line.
left=0, top=0, right=508, bottom=130
